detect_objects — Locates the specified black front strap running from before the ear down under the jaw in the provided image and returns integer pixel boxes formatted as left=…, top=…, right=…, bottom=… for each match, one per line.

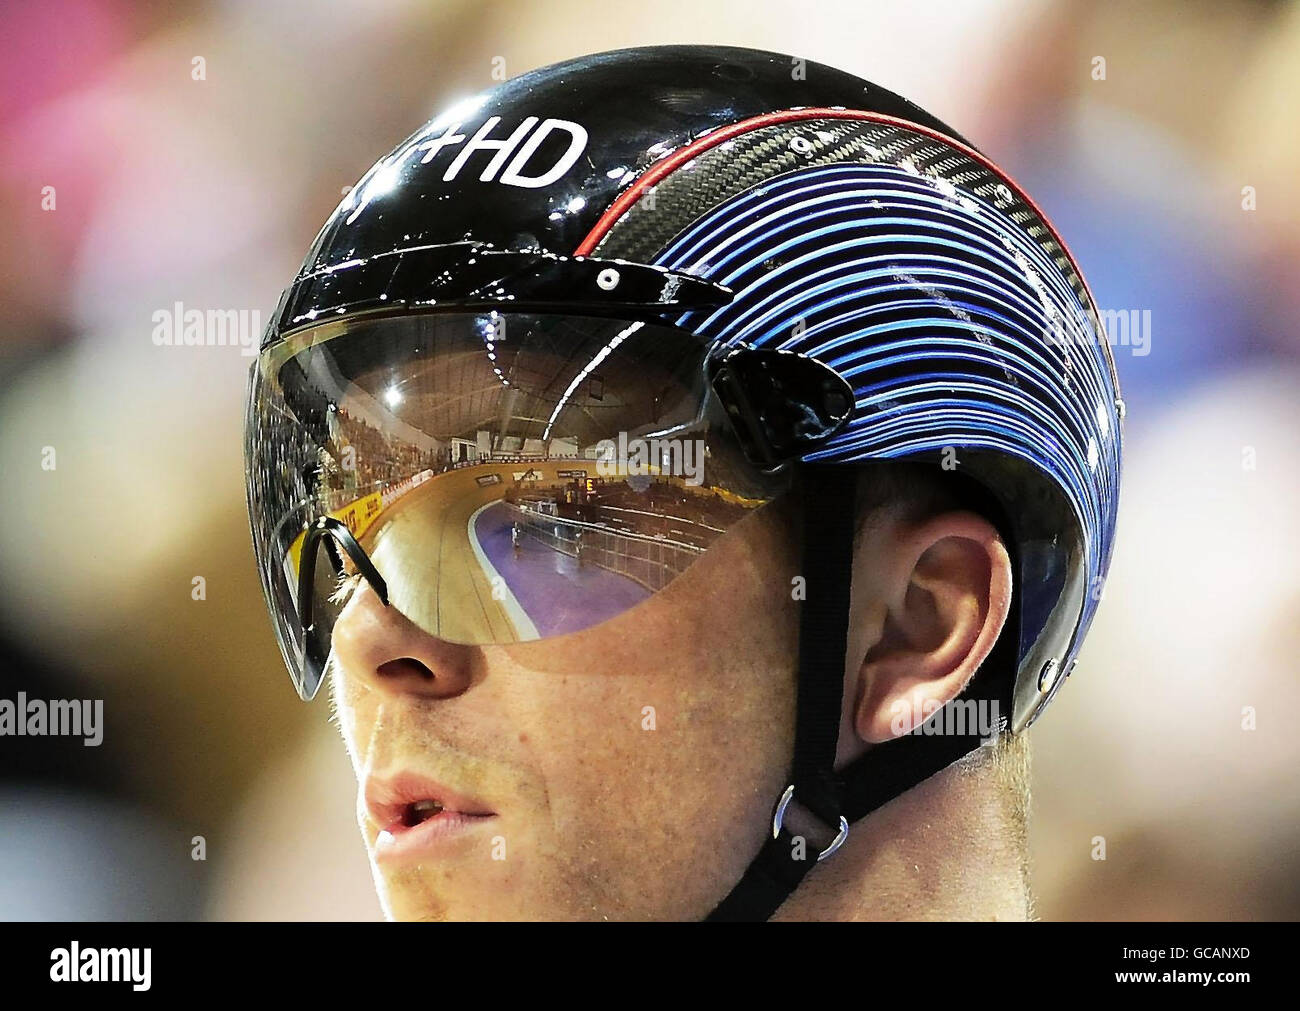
left=709, top=464, right=857, bottom=920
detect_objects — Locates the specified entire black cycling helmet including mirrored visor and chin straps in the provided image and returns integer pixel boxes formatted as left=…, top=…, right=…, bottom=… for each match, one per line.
left=246, top=45, right=1123, bottom=919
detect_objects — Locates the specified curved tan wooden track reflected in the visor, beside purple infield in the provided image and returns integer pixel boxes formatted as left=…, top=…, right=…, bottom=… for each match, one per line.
left=361, top=460, right=594, bottom=643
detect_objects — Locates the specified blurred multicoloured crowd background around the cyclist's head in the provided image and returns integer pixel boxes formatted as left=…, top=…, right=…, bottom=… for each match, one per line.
left=0, top=0, right=1300, bottom=920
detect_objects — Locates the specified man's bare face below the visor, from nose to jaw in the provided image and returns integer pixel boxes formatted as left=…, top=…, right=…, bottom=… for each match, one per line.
left=330, top=503, right=798, bottom=920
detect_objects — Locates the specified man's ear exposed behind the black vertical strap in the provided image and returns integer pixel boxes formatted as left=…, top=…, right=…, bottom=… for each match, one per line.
left=852, top=512, right=1011, bottom=743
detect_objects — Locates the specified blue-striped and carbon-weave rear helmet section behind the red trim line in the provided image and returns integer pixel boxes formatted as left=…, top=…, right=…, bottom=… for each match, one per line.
left=590, top=109, right=1123, bottom=729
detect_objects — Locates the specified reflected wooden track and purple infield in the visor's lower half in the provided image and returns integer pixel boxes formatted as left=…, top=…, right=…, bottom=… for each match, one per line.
left=360, top=457, right=751, bottom=643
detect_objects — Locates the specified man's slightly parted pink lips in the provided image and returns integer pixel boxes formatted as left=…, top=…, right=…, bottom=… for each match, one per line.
left=364, top=772, right=497, bottom=860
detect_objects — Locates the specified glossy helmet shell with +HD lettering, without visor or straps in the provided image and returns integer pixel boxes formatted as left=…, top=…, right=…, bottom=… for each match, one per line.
left=265, top=47, right=1123, bottom=730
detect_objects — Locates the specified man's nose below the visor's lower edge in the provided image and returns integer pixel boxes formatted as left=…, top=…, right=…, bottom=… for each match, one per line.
left=332, top=583, right=473, bottom=698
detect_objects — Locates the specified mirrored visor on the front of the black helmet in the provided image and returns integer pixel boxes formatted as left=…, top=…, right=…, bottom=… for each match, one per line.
left=246, top=312, right=785, bottom=698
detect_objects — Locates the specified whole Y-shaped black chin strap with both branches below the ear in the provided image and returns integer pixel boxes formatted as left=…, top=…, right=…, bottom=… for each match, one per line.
left=707, top=464, right=984, bottom=921
